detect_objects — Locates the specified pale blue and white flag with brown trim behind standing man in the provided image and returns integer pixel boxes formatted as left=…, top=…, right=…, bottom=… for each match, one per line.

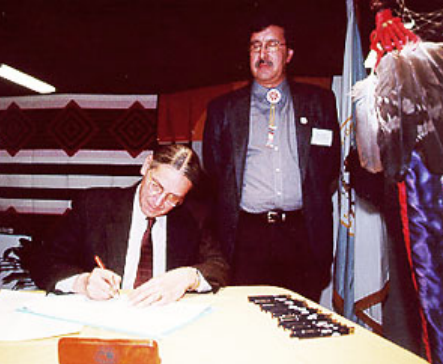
left=333, top=0, right=388, bottom=332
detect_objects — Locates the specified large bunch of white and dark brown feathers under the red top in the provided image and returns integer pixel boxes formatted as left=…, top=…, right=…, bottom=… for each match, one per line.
left=354, top=42, right=443, bottom=181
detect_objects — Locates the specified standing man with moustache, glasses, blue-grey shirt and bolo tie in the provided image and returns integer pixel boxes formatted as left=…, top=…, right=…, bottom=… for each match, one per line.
left=203, top=16, right=340, bottom=301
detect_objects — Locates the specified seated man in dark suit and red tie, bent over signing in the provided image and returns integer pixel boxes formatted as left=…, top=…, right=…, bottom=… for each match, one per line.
left=31, top=145, right=228, bottom=306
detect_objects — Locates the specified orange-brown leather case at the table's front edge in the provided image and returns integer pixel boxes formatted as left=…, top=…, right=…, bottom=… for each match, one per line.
left=58, top=337, right=161, bottom=364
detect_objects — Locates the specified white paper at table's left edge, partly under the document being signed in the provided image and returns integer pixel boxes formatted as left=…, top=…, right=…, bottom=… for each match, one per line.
left=0, top=289, right=83, bottom=341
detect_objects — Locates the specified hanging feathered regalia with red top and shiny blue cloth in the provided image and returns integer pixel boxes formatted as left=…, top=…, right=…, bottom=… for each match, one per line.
left=353, top=5, right=443, bottom=363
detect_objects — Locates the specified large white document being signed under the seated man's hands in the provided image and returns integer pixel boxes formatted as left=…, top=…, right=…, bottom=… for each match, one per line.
left=19, top=294, right=211, bottom=339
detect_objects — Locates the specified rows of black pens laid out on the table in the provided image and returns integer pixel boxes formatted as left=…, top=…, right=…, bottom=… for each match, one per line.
left=248, top=295, right=354, bottom=339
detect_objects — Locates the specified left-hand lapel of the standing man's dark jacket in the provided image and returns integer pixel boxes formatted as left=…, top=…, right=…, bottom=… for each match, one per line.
left=231, top=86, right=251, bottom=196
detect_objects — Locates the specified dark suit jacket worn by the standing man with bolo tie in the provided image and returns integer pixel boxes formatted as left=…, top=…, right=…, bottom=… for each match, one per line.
left=203, top=83, right=340, bottom=274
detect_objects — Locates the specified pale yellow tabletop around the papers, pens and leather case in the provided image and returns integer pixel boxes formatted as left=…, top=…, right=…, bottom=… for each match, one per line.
left=0, top=286, right=427, bottom=364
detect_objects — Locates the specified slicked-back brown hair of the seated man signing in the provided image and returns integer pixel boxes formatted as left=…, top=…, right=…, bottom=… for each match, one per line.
left=151, top=144, right=202, bottom=186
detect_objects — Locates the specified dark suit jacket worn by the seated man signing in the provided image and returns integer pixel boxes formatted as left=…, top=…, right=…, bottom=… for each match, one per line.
left=31, top=186, right=228, bottom=291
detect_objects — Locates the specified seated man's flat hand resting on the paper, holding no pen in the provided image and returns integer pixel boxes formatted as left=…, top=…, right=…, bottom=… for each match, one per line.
left=129, top=267, right=198, bottom=307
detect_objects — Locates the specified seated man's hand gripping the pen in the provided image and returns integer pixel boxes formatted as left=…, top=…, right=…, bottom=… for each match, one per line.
left=74, top=268, right=121, bottom=300
